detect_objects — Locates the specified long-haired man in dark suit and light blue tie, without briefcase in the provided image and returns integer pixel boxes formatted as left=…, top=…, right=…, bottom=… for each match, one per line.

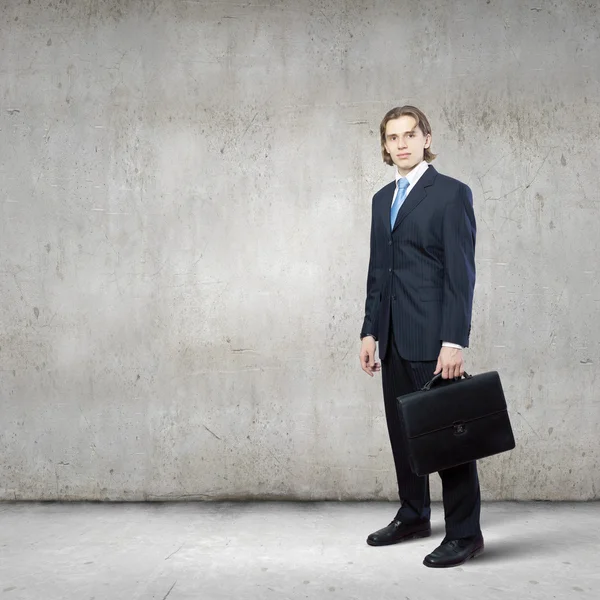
left=360, top=106, right=483, bottom=567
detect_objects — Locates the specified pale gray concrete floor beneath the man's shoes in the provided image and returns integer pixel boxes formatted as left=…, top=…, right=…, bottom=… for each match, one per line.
left=0, top=503, right=600, bottom=600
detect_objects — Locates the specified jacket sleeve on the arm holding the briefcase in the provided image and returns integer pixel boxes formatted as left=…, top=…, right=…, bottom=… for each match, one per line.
left=440, top=184, right=476, bottom=347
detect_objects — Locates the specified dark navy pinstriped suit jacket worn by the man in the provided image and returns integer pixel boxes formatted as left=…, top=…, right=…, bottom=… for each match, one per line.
left=361, top=165, right=476, bottom=362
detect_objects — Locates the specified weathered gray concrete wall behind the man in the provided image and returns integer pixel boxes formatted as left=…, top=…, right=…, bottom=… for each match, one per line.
left=0, top=0, right=600, bottom=500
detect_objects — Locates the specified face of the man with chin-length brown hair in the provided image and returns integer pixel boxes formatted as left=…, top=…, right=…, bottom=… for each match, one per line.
left=384, top=116, right=431, bottom=175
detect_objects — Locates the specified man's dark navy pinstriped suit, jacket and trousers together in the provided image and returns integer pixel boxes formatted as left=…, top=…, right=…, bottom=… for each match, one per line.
left=362, top=167, right=480, bottom=539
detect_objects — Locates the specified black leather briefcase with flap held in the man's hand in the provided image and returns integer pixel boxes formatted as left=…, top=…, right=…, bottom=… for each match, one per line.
left=398, top=371, right=515, bottom=475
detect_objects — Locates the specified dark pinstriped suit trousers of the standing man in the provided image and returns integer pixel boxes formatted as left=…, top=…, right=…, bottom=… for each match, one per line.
left=381, top=327, right=481, bottom=540
